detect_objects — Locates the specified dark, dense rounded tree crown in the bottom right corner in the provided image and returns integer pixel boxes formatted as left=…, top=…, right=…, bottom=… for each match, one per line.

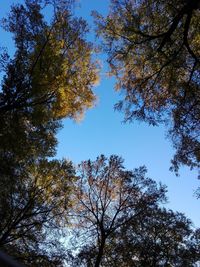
left=103, top=208, right=200, bottom=267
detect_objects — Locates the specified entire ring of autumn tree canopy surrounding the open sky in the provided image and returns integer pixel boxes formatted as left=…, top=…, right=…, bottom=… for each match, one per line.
left=0, top=0, right=200, bottom=267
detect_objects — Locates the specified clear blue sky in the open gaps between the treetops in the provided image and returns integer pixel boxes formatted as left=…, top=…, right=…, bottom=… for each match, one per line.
left=0, top=0, right=200, bottom=227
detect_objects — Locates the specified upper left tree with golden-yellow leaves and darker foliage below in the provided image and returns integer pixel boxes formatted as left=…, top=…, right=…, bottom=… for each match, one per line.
left=0, top=0, right=98, bottom=182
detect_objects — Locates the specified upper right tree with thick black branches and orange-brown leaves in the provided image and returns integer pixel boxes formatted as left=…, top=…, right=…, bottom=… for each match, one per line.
left=95, top=0, right=200, bottom=176
